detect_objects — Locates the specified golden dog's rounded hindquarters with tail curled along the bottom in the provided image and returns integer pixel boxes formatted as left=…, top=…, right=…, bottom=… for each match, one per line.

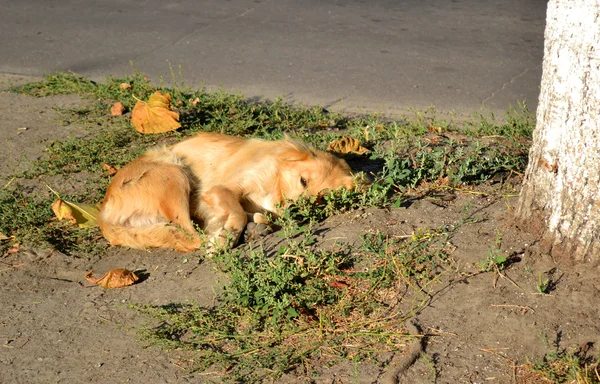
left=99, top=161, right=203, bottom=252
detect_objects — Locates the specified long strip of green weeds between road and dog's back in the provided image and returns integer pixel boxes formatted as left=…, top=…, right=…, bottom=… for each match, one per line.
left=13, top=73, right=534, bottom=188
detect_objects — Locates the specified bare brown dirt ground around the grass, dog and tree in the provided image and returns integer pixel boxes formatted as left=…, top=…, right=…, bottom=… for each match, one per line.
left=0, top=76, right=600, bottom=383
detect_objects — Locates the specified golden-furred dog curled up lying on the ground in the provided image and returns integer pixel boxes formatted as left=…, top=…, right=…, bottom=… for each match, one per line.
left=98, top=132, right=354, bottom=252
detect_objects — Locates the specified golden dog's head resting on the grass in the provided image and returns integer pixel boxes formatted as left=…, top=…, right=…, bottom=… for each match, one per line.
left=279, top=139, right=355, bottom=204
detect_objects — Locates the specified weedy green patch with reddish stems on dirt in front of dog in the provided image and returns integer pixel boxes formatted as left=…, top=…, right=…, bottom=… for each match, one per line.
left=135, top=215, right=450, bottom=382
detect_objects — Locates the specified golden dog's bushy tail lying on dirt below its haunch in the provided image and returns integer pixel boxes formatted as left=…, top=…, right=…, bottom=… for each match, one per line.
left=100, top=220, right=204, bottom=252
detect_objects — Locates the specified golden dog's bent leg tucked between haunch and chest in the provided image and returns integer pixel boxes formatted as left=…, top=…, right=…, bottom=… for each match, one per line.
left=199, top=186, right=248, bottom=252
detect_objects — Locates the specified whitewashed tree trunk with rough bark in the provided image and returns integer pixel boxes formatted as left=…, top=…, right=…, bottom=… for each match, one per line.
left=517, top=0, right=600, bottom=263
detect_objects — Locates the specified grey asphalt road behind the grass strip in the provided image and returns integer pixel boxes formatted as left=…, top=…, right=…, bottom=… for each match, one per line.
left=0, top=0, right=546, bottom=114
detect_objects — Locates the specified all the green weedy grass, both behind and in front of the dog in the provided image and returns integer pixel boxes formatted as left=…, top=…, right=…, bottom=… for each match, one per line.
left=0, top=73, right=535, bottom=382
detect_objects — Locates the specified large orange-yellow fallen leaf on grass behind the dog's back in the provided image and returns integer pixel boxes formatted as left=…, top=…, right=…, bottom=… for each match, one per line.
left=131, top=91, right=181, bottom=134
